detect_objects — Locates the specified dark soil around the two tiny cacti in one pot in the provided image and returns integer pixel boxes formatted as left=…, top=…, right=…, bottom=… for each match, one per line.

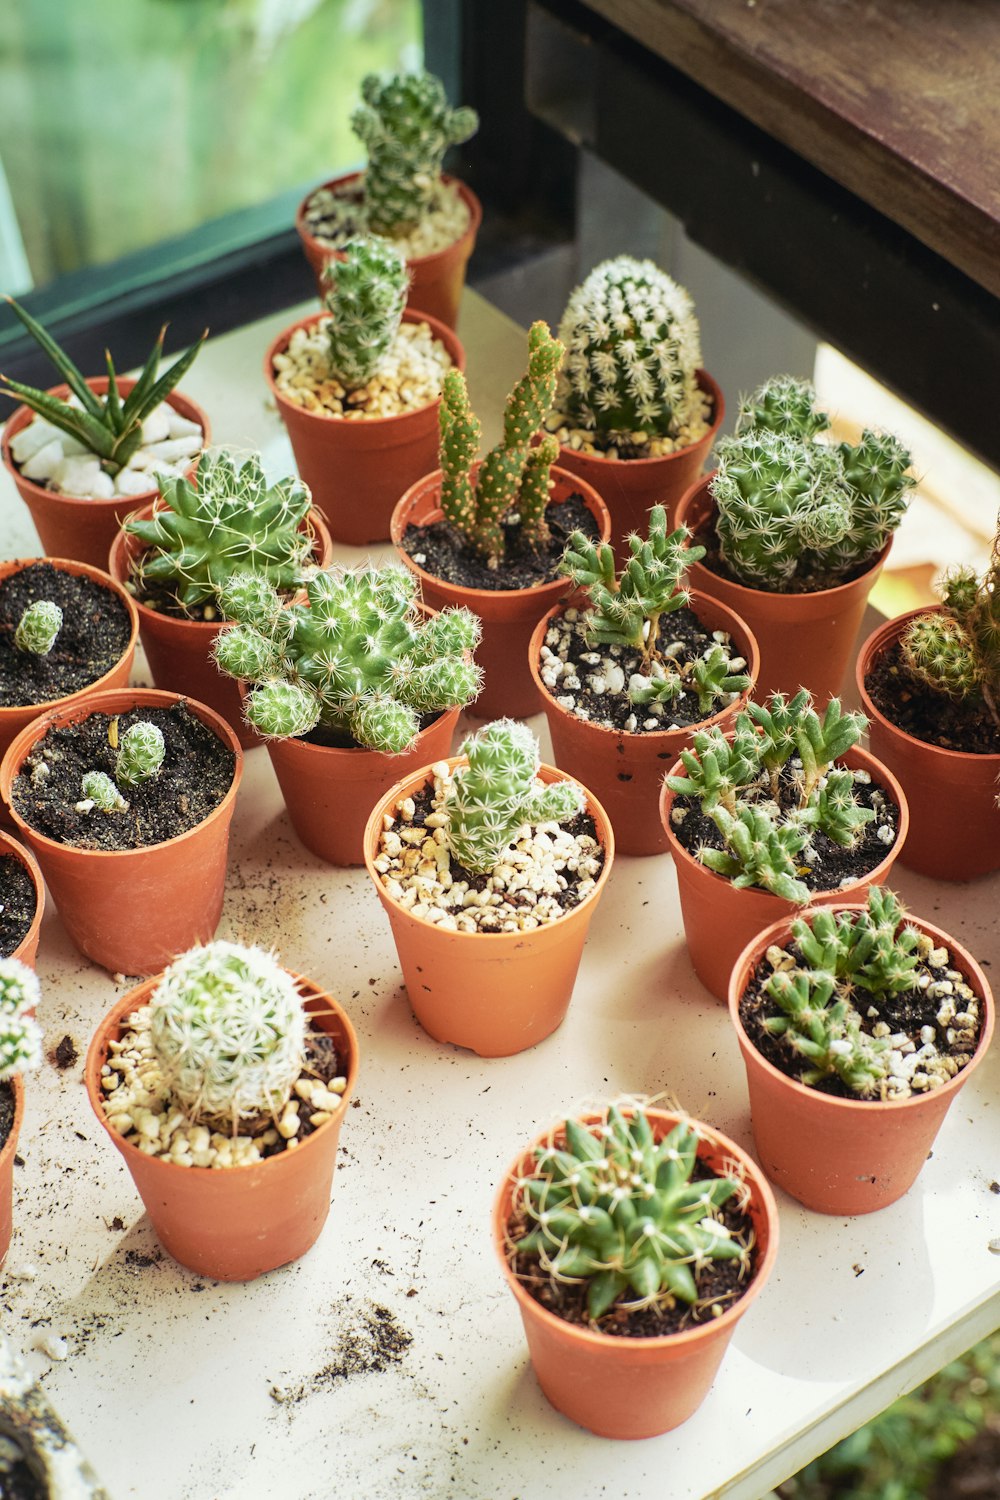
left=12, top=702, right=235, bottom=851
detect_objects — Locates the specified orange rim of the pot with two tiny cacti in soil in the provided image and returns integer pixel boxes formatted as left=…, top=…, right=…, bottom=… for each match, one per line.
left=0, top=687, right=243, bottom=860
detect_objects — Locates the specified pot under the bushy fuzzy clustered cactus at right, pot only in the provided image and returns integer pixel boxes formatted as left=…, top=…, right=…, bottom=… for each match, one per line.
left=678, top=474, right=892, bottom=710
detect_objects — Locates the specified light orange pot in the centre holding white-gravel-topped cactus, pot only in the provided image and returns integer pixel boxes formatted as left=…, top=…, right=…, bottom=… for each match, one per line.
left=364, top=756, right=615, bottom=1058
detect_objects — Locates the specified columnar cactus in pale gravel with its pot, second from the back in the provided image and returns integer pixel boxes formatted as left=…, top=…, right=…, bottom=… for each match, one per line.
left=264, top=237, right=465, bottom=546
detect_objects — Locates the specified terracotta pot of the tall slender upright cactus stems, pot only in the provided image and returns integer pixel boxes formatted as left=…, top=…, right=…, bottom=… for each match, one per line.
left=391, top=464, right=612, bottom=719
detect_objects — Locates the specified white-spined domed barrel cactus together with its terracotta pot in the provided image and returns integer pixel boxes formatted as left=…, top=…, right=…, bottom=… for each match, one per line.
left=546, top=255, right=724, bottom=552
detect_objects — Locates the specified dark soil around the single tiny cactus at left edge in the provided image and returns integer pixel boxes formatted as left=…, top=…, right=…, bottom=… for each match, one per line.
left=0, top=563, right=132, bottom=708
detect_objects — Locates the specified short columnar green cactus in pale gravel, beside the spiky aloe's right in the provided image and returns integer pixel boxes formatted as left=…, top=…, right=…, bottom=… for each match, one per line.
left=322, top=239, right=409, bottom=390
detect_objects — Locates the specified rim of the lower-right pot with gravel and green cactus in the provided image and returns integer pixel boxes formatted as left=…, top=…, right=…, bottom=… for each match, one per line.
left=727, top=902, right=996, bottom=1119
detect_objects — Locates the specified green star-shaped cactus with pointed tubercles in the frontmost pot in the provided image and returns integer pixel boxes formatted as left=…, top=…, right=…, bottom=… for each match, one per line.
left=513, top=1106, right=748, bottom=1322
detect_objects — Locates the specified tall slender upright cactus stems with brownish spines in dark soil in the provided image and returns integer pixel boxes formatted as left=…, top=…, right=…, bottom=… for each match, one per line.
left=439, top=323, right=562, bottom=567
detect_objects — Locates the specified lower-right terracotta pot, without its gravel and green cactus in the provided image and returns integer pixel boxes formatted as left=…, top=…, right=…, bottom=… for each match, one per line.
left=729, top=902, right=996, bottom=1215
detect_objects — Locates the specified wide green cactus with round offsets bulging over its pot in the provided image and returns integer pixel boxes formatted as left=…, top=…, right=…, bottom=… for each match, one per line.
left=213, top=566, right=481, bottom=755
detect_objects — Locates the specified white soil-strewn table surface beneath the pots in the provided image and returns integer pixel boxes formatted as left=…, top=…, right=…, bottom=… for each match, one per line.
left=0, top=294, right=1000, bottom=1500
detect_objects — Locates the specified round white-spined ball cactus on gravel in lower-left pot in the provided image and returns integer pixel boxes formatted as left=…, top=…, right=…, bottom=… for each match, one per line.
left=150, top=941, right=306, bottom=1134
